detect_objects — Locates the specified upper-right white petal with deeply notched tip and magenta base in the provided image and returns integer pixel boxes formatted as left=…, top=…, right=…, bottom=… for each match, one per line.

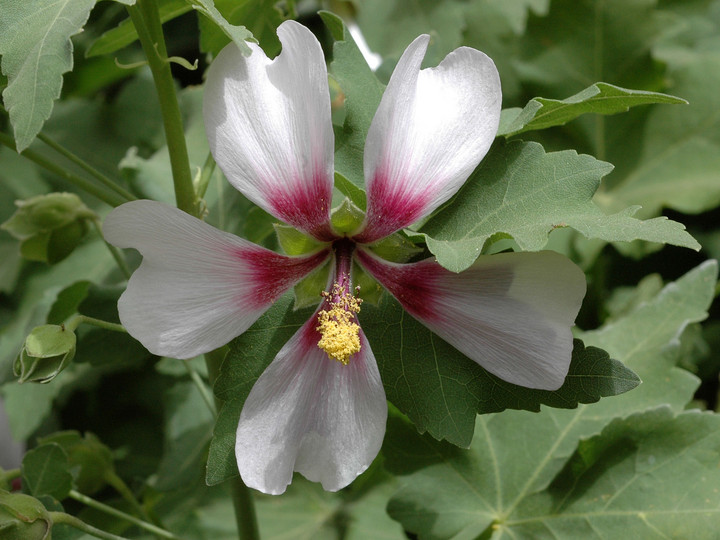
left=358, top=35, right=502, bottom=242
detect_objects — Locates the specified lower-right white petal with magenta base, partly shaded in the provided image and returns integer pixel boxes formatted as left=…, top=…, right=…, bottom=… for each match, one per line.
left=357, top=249, right=586, bottom=390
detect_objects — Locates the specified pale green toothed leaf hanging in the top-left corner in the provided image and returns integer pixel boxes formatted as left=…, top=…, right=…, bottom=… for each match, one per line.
left=0, top=0, right=95, bottom=152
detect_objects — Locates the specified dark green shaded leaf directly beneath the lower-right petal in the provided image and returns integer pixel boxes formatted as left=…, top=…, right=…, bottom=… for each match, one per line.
left=360, top=295, right=640, bottom=447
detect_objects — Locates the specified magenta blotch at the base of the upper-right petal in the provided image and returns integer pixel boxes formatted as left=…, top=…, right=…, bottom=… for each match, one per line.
left=354, top=171, right=432, bottom=243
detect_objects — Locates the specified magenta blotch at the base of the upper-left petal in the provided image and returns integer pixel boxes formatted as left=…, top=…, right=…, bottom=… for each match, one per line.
left=266, top=170, right=337, bottom=242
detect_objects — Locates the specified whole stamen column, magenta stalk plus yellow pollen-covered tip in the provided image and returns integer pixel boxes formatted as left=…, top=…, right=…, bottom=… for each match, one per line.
left=315, top=239, right=362, bottom=365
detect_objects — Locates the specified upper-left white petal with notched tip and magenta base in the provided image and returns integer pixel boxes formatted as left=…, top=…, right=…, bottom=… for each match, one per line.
left=203, top=21, right=334, bottom=240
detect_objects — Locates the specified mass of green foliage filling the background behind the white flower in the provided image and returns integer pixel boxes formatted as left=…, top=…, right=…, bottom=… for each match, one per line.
left=0, top=0, right=720, bottom=540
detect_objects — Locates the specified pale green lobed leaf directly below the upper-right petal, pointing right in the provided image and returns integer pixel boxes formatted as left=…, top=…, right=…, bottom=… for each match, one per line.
left=421, top=141, right=699, bottom=272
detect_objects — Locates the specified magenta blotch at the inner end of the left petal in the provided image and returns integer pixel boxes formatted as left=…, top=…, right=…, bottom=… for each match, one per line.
left=234, top=247, right=330, bottom=308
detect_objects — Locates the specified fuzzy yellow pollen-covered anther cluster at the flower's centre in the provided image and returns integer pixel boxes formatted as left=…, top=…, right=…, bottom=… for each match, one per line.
left=315, top=283, right=362, bottom=366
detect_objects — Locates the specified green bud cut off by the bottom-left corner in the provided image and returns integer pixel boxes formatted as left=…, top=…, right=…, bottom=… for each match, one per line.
left=0, top=490, right=52, bottom=540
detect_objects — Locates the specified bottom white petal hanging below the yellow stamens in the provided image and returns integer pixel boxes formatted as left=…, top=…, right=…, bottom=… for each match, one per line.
left=235, top=313, right=387, bottom=495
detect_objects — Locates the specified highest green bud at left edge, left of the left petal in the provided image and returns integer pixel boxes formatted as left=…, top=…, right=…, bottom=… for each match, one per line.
left=0, top=193, right=95, bottom=264
